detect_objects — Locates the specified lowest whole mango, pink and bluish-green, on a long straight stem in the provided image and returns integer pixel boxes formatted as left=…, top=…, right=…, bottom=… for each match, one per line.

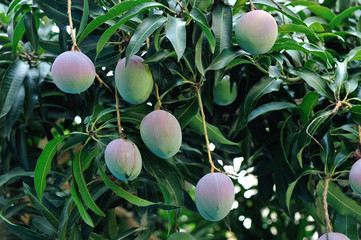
left=195, top=172, right=235, bottom=221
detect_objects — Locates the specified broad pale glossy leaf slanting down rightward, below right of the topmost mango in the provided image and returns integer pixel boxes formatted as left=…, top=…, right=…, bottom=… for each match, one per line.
left=291, top=67, right=334, bottom=100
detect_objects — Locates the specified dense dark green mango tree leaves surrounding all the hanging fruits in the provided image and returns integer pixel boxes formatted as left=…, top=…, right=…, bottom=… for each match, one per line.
left=0, top=0, right=361, bottom=240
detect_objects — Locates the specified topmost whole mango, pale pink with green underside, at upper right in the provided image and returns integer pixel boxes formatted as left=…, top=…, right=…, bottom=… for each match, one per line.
left=235, top=10, right=278, bottom=54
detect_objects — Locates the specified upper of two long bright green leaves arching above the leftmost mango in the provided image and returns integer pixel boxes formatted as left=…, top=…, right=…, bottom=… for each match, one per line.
left=78, top=0, right=152, bottom=44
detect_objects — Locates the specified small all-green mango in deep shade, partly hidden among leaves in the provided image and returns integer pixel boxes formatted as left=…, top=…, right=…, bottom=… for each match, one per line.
left=213, top=75, right=237, bottom=106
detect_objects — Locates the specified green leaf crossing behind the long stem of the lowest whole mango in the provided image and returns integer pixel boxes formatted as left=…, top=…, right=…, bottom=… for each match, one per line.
left=189, top=112, right=238, bottom=145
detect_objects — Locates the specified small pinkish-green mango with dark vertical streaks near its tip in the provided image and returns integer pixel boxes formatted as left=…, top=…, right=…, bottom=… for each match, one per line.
left=104, top=138, right=142, bottom=181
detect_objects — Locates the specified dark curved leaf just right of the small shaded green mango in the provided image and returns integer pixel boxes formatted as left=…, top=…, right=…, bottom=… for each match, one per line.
left=244, top=77, right=282, bottom=117
